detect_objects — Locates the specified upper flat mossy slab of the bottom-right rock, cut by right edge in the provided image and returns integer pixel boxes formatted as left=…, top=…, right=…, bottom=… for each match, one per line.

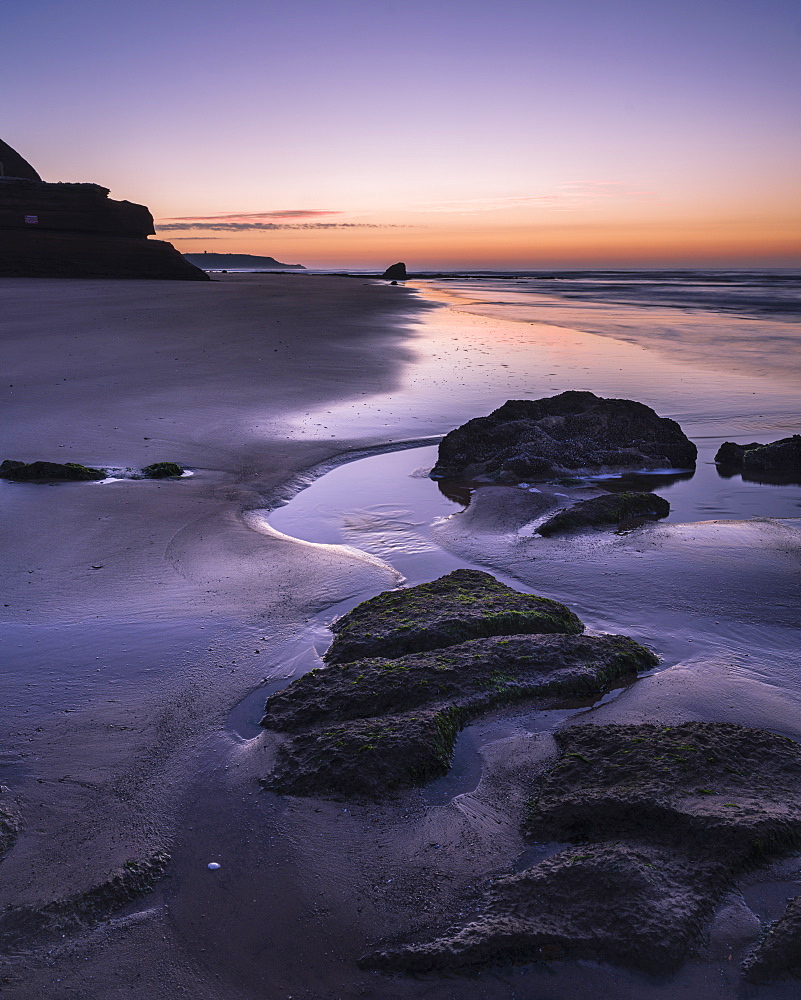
left=526, top=722, right=801, bottom=861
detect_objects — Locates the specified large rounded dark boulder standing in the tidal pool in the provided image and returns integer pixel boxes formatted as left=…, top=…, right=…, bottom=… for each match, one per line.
left=431, top=391, right=697, bottom=481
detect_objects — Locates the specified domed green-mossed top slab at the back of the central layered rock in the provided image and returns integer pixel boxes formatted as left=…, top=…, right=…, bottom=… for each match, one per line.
left=323, top=569, right=584, bottom=663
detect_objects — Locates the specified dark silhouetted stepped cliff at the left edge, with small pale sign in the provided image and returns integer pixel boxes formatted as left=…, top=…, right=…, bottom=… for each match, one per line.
left=0, top=140, right=209, bottom=281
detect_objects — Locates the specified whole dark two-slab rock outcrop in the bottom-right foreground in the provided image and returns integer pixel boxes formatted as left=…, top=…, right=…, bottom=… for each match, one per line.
left=361, top=722, right=801, bottom=973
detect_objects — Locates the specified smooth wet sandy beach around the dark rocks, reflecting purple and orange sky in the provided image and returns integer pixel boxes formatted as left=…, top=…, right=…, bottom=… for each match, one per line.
left=0, top=274, right=801, bottom=1000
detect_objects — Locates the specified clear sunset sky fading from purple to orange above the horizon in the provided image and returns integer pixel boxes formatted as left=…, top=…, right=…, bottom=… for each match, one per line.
left=0, top=0, right=801, bottom=269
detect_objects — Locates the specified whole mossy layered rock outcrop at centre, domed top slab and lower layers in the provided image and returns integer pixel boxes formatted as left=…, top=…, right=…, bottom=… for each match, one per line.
left=262, top=571, right=657, bottom=799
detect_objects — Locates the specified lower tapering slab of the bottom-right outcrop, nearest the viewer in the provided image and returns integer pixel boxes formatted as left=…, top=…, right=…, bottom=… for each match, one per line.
left=359, top=843, right=725, bottom=973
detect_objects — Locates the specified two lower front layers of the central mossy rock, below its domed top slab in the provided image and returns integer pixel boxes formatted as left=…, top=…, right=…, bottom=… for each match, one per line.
left=262, top=635, right=657, bottom=798
